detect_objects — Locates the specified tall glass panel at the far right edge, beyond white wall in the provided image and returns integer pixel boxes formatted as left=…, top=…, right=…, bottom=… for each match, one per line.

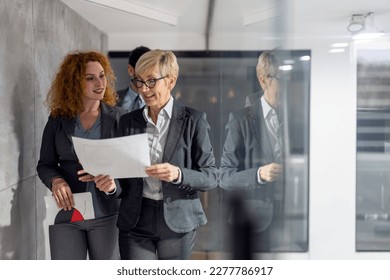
left=356, top=49, right=390, bottom=251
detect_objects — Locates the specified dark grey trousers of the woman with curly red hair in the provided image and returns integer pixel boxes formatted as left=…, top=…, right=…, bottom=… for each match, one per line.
left=49, top=214, right=119, bottom=260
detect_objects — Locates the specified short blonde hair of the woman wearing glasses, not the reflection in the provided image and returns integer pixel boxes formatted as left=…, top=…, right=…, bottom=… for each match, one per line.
left=135, top=50, right=179, bottom=78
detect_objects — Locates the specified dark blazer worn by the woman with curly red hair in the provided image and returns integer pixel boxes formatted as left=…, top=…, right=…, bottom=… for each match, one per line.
left=37, top=103, right=124, bottom=215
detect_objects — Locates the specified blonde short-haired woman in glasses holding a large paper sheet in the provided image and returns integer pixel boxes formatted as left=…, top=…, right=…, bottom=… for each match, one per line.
left=105, top=50, right=217, bottom=259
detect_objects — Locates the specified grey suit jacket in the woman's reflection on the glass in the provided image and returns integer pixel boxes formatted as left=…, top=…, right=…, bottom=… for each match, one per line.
left=220, top=99, right=275, bottom=231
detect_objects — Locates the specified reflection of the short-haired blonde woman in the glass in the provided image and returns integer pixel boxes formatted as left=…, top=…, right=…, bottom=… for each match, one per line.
left=220, top=51, right=283, bottom=254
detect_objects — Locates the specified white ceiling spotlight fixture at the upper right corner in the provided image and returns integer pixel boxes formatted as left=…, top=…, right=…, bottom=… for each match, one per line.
left=347, top=12, right=384, bottom=40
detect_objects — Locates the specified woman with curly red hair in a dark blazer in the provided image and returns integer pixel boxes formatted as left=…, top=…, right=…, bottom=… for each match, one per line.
left=37, top=51, right=124, bottom=259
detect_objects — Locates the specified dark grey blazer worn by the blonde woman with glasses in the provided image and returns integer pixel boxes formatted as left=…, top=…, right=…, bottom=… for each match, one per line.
left=116, top=101, right=217, bottom=233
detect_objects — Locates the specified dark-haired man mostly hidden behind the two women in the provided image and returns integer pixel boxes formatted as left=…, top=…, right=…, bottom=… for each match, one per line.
left=117, top=46, right=150, bottom=112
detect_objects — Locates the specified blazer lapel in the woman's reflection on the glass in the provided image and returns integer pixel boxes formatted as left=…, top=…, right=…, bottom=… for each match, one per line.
left=250, top=99, right=274, bottom=162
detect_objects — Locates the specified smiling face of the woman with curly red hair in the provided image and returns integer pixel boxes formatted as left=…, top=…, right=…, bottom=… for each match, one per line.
left=82, top=61, right=107, bottom=102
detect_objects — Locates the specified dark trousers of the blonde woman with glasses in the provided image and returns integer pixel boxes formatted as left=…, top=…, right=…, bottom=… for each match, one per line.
left=119, top=198, right=195, bottom=260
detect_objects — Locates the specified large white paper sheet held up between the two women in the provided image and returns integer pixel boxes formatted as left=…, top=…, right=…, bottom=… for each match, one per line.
left=72, top=133, right=150, bottom=179
